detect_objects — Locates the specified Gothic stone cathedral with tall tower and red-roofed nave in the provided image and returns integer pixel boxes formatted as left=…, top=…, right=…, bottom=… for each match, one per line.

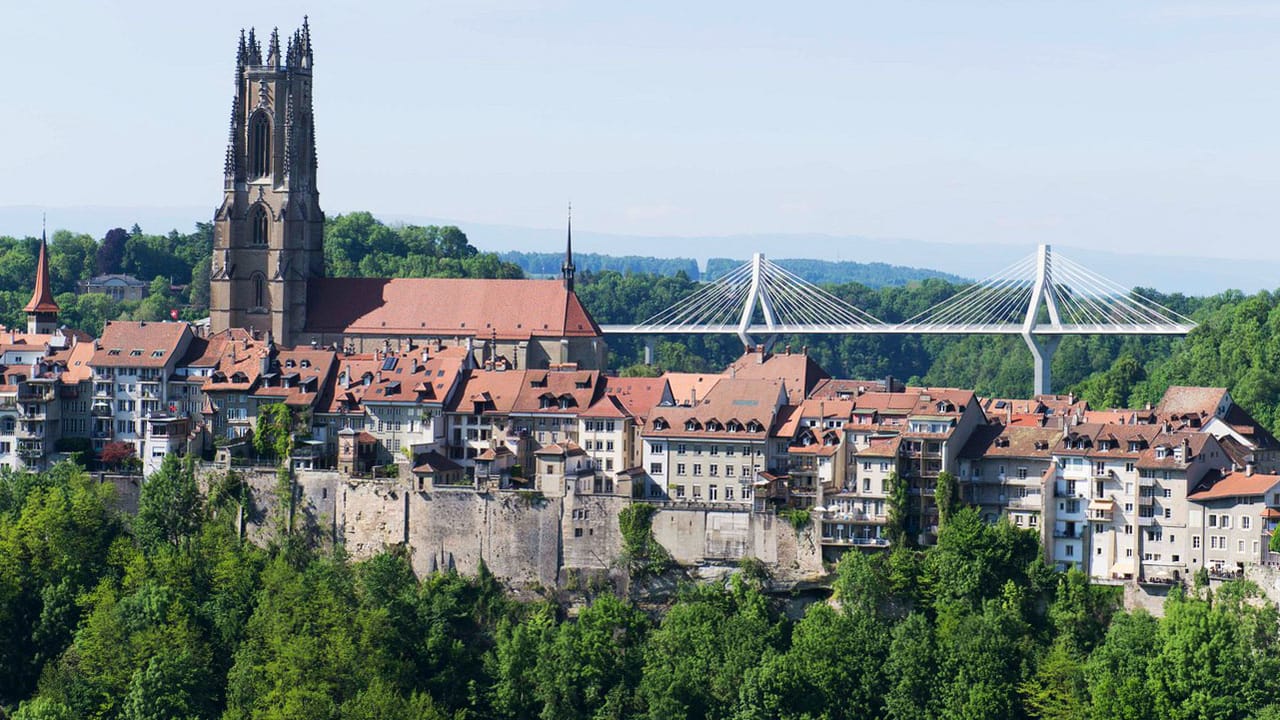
left=210, top=20, right=607, bottom=369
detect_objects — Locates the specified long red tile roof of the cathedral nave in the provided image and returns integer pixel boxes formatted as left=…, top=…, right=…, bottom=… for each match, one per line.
left=306, top=278, right=600, bottom=340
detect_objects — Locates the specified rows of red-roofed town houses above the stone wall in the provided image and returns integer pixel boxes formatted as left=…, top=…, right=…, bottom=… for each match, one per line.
left=0, top=230, right=1280, bottom=584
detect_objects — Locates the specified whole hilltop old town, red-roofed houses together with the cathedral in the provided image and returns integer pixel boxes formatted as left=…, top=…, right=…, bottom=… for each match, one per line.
left=0, top=23, right=1280, bottom=594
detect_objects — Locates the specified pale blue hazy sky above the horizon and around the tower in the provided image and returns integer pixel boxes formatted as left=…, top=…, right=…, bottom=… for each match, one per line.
left=0, top=0, right=1280, bottom=259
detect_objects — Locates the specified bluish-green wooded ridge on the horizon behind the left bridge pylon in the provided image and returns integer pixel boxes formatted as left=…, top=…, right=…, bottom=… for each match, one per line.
left=498, top=251, right=966, bottom=287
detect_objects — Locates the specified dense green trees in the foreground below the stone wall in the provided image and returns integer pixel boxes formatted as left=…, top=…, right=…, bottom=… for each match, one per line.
left=0, top=456, right=1280, bottom=720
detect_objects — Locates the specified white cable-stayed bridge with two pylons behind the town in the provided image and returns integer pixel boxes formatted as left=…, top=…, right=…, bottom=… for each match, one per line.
left=600, top=245, right=1196, bottom=393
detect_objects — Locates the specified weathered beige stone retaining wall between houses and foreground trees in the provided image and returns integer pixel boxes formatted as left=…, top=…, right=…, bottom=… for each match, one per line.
left=215, top=469, right=823, bottom=588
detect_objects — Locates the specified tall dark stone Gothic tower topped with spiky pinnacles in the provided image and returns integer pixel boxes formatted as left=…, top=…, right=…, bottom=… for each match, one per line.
left=209, top=19, right=324, bottom=345
